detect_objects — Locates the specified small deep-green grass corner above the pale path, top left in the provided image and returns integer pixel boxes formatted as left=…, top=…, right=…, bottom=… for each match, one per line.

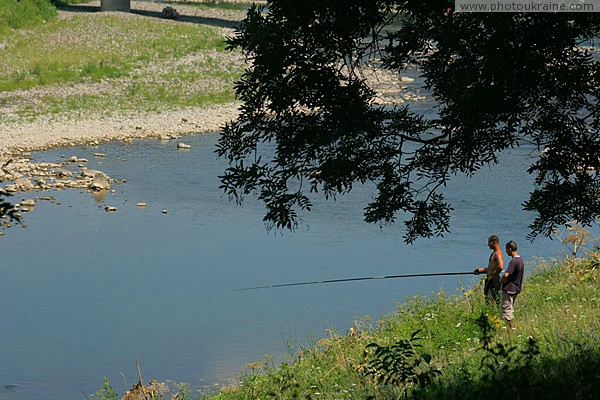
left=0, top=0, right=56, bottom=35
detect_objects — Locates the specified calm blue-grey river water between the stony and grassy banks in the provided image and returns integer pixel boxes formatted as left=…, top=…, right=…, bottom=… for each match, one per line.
left=0, top=129, right=596, bottom=400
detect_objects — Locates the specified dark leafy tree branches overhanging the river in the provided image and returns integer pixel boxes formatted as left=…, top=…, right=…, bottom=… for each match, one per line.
left=217, top=0, right=600, bottom=242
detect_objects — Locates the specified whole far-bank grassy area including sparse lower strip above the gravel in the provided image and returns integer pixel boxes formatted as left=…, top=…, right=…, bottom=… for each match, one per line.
left=0, top=13, right=243, bottom=123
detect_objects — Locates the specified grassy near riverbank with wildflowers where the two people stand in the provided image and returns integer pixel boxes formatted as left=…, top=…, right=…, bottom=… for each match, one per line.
left=90, top=251, right=600, bottom=400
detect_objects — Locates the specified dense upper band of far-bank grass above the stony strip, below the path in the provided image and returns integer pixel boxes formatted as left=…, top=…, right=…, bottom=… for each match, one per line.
left=0, top=15, right=230, bottom=92
